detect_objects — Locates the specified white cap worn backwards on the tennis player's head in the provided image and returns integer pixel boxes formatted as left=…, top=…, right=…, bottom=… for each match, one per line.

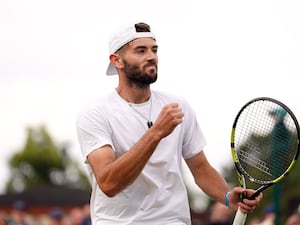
left=106, top=24, right=155, bottom=75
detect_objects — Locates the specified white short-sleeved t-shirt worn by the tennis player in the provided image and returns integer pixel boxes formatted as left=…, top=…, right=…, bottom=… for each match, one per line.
left=77, top=91, right=206, bottom=225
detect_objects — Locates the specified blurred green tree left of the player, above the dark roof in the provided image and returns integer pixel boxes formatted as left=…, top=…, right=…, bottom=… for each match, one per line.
left=6, top=126, right=90, bottom=192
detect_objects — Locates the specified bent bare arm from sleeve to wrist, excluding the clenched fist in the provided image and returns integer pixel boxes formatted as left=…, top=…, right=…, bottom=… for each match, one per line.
left=87, top=130, right=160, bottom=197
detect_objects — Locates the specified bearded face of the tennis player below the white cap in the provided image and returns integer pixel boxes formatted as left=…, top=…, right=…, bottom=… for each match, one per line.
left=122, top=38, right=158, bottom=87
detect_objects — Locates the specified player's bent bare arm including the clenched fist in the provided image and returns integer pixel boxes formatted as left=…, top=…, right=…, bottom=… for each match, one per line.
left=87, top=103, right=183, bottom=197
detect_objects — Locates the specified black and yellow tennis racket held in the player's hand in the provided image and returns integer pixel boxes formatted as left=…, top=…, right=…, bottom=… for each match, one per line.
left=231, top=97, right=300, bottom=225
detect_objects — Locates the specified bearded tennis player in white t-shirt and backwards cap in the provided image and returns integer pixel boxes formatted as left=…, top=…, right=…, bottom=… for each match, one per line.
left=77, top=23, right=262, bottom=225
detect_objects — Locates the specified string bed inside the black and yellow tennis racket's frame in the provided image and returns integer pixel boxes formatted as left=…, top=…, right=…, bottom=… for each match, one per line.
left=234, top=101, right=298, bottom=182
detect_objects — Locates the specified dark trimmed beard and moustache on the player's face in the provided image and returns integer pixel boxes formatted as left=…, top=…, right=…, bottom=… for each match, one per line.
left=123, top=60, right=157, bottom=88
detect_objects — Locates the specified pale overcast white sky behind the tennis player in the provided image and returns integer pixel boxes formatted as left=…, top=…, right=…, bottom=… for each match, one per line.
left=0, top=0, right=300, bottom=199
